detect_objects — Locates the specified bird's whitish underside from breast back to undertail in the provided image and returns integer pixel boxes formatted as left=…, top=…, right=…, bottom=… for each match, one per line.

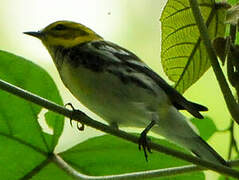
left=61, top=64, right=196, bottom=144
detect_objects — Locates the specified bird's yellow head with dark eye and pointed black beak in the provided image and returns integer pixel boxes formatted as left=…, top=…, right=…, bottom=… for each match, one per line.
left=25, top=21, right=102, bottom=48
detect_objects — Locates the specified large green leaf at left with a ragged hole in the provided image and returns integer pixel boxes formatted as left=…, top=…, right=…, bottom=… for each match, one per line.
left=0, top=51, right=64, bottom=180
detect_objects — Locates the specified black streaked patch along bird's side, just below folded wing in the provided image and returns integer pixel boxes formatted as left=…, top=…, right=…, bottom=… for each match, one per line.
left=51, top=43, right=156, bottom=95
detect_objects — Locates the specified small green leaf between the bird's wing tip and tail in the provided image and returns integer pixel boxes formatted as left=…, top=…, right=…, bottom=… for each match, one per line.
left=191, top=117, right=217, bottom=140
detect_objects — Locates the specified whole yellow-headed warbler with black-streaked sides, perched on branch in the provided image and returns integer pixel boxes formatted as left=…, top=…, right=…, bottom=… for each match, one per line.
left=25, top=21, right=227, bottom=165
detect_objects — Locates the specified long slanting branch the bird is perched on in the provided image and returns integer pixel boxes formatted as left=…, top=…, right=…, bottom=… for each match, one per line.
left=0, top=80, right=239, bottom=178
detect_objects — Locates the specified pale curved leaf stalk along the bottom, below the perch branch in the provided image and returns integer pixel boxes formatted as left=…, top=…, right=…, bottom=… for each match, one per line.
left=53, top=155, right=239, bottom=180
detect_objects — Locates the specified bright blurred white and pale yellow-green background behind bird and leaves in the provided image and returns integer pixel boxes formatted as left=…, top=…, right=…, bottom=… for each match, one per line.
left=0, top=0, right=236, bottom=178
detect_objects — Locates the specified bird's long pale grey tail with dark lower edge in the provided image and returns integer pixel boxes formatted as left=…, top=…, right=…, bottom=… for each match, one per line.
left=152, top=106, right=229, bottom=166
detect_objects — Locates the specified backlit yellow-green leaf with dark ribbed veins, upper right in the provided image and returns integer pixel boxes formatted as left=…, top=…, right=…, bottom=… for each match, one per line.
left=161, top=0, right=228, bottom=93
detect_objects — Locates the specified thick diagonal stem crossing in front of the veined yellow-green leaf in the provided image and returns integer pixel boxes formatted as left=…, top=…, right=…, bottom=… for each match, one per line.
left=189, top=0, right=239, bottom=124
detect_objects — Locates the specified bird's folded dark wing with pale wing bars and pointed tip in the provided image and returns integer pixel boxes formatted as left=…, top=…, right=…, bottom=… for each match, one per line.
left=80, top=41, right=208, bottom=119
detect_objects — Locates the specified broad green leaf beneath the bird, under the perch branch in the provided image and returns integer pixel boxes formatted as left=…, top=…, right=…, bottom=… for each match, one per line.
left=60, top=135, right=204, bottom=180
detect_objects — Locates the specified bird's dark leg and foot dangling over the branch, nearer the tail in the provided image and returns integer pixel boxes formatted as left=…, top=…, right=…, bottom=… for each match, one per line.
left=139, top=120, right=156, bottom=161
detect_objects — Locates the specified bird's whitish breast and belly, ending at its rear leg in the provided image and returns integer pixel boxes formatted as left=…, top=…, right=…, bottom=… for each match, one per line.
left=60, top=59, right=169, bottom=127
